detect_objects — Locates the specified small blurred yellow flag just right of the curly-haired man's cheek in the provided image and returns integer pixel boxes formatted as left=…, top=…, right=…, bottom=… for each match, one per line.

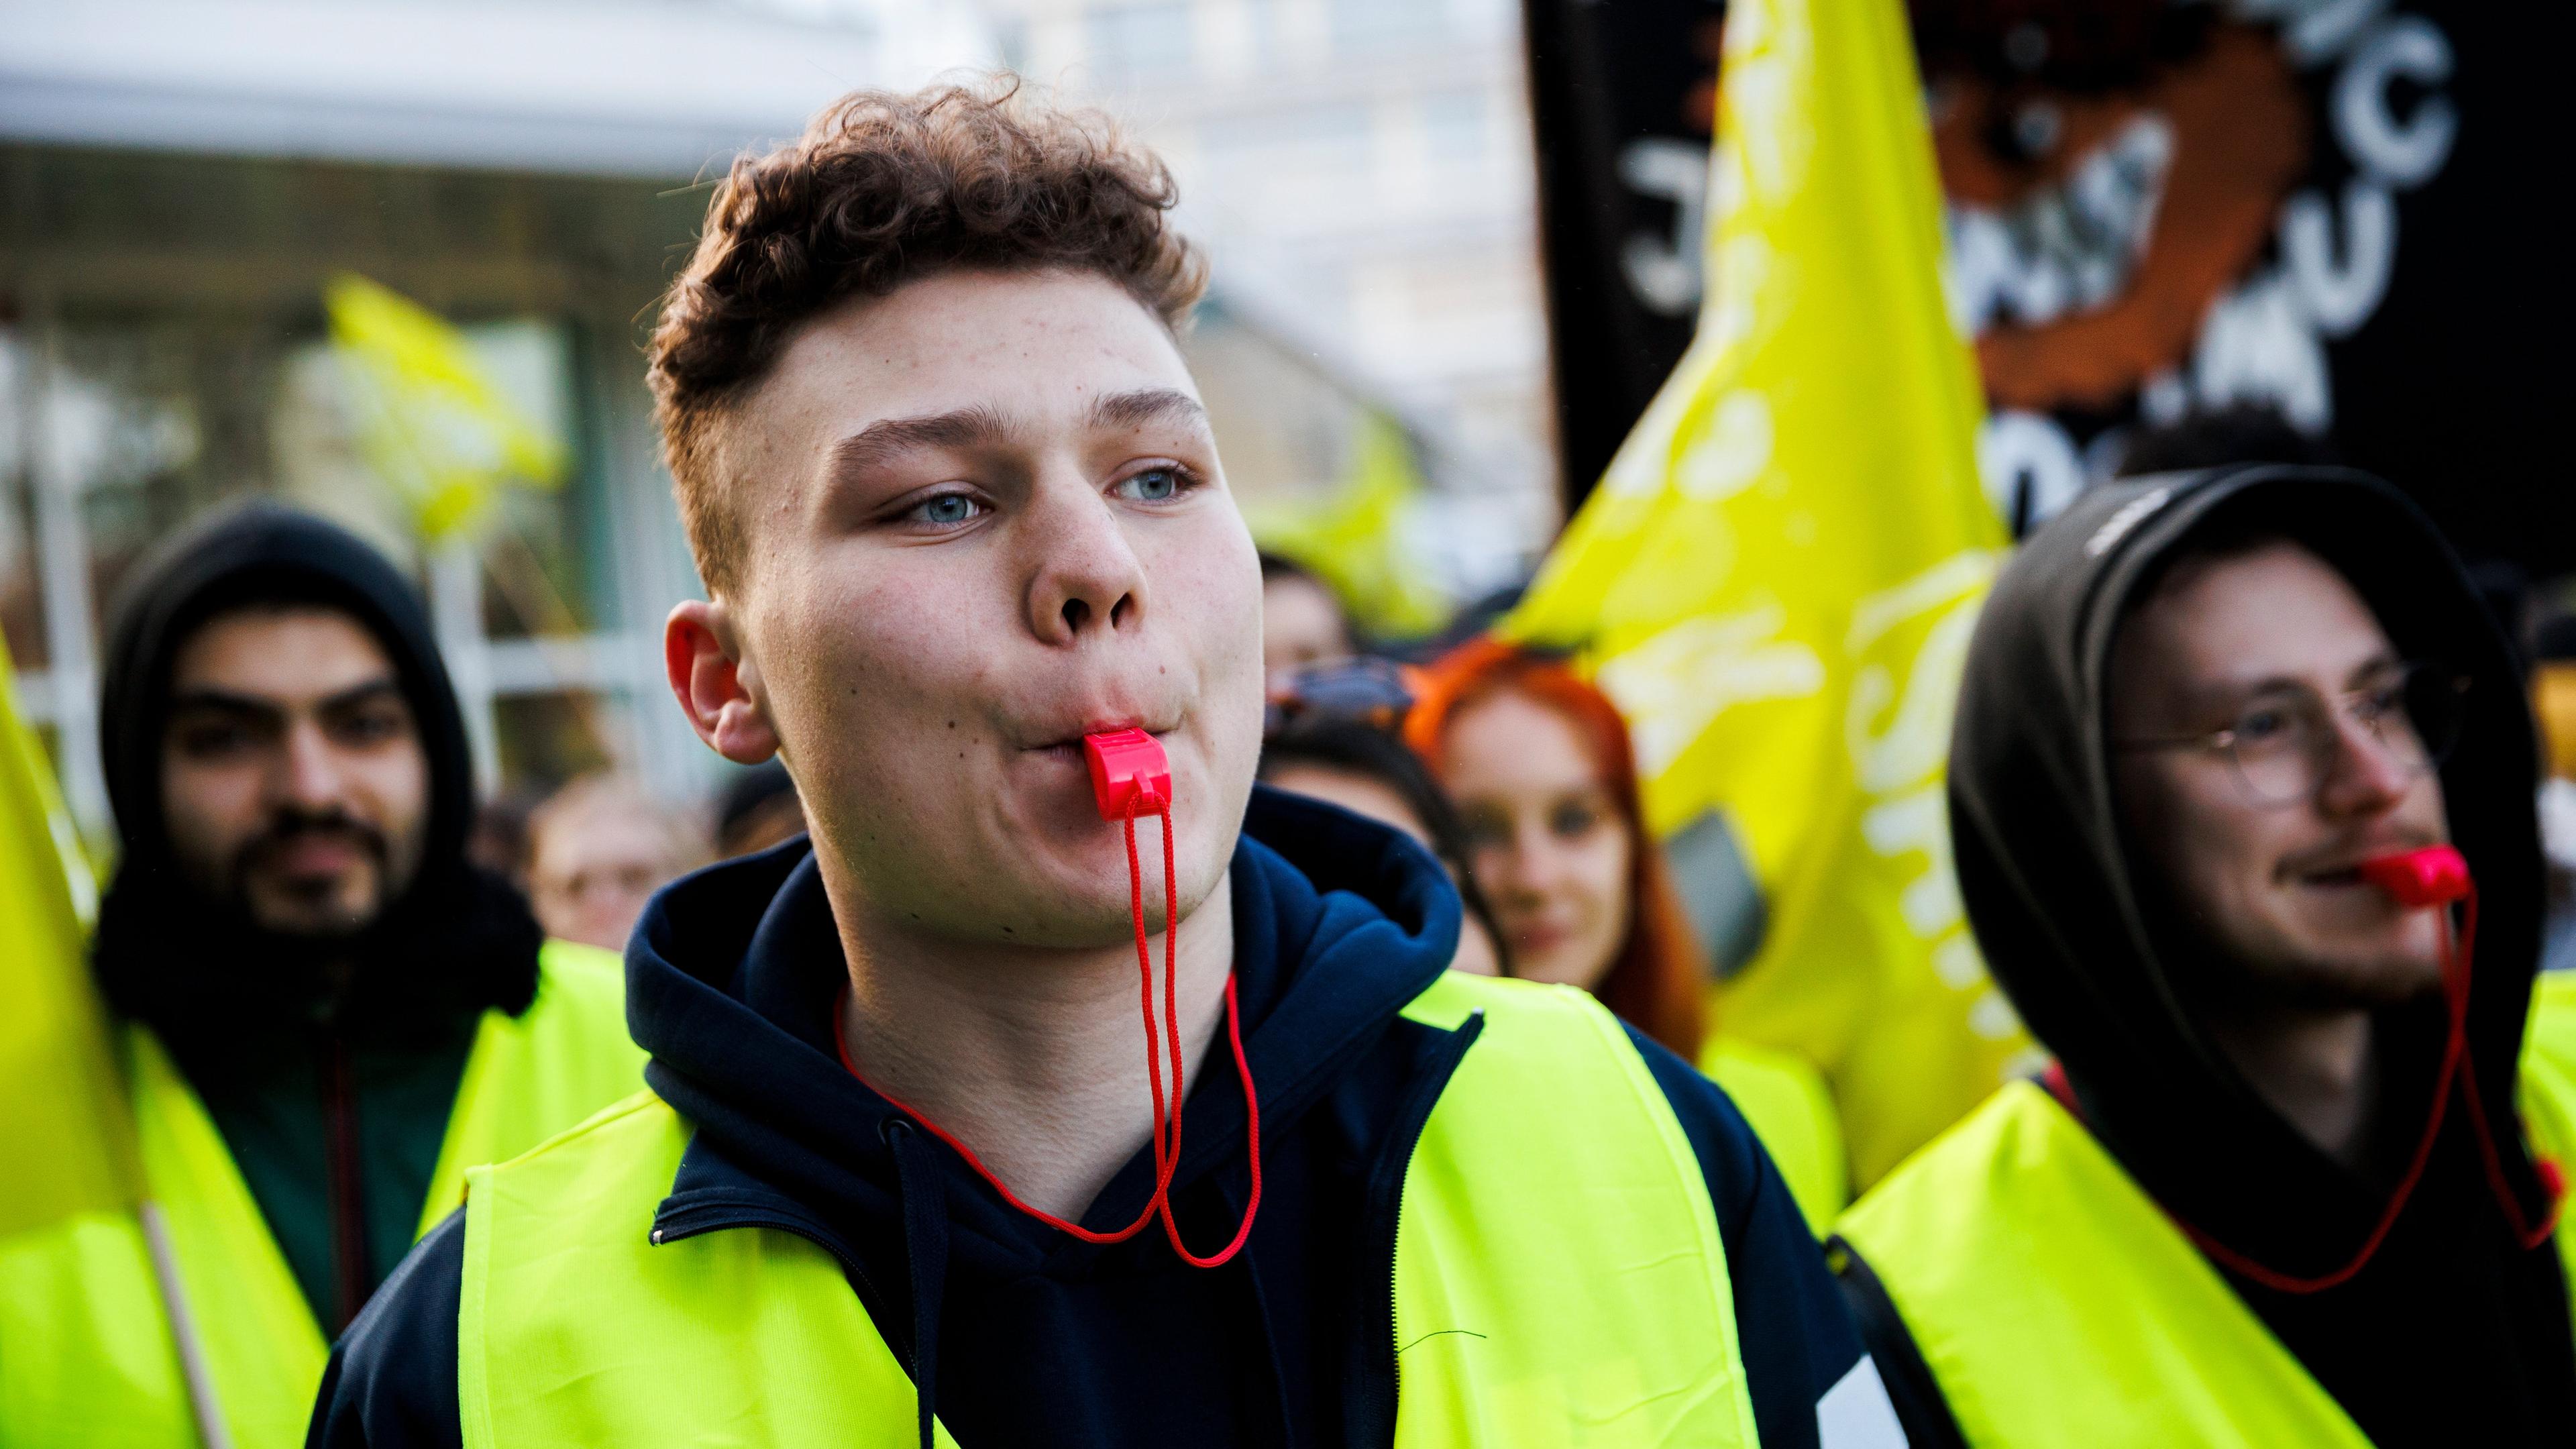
left=1249, top=413, right=1450, bottom=639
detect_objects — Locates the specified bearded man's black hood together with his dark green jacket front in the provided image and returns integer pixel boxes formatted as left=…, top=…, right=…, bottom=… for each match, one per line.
left=93, top=505, right=543, bottom=1326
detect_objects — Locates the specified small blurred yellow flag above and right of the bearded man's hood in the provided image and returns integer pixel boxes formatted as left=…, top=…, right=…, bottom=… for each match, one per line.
left=325, top=276, right=564, bottom=544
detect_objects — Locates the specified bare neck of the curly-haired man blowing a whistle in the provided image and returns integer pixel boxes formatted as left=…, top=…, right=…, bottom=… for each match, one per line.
left=827, top=874, right=1234, bottom=1222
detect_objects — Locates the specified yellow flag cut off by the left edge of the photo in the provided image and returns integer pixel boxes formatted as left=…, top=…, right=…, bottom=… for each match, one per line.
left=0, top=631, right=142, bottom=1238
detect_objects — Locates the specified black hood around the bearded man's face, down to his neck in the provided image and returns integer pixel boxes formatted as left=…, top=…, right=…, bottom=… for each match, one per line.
left=93, top=502, right=543, bottom=1034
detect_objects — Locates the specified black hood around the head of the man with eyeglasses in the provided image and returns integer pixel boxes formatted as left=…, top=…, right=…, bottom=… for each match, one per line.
left=1950, top=464, right=2545, bottom=1271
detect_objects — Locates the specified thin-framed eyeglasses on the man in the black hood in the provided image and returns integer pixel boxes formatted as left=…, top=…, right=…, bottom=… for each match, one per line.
left=2112, top=663, right=2468, bottom=807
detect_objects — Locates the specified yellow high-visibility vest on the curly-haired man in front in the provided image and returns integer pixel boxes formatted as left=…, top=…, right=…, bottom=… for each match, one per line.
left=456, top=975, right=1754, bottom=1449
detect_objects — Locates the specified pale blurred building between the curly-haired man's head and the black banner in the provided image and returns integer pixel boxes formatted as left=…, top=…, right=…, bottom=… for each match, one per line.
left=987, top=0, right=1558, bottom=596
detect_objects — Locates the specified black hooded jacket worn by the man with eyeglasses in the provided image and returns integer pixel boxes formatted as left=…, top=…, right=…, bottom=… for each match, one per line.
left=1844, top=467, right=2576, bottom=1446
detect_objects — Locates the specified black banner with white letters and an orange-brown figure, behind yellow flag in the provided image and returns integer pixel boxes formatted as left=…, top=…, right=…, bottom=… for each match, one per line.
left=1530, top=0, right=2576, bottom=575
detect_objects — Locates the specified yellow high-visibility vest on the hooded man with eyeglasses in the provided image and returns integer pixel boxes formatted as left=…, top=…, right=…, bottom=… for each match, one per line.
left=1842, top=977, right=2576, bottom=1449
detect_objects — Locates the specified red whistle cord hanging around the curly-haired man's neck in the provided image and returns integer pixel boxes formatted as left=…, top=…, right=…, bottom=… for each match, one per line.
left=832, top=792, right=1263, bottom=1269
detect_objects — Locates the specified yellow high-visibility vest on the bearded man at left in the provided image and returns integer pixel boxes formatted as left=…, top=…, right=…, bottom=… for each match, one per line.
left=0, top=941, right=644, bottom=1449
